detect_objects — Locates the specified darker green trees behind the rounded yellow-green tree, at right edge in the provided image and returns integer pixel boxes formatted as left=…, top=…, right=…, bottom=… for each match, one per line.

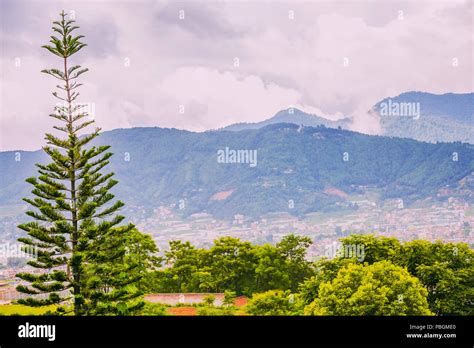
left=341, top=235, right=474, bottom=315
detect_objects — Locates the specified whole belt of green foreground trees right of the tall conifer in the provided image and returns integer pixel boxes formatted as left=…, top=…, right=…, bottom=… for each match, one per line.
left=147, top=235, right=474, bottom=315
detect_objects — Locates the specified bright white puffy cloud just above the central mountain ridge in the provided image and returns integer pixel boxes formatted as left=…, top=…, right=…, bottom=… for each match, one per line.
left=145, top=66, right=300, bottom=131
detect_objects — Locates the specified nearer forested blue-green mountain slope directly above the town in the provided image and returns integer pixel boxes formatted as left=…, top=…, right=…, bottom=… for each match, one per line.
left=0, top=124, right=474, bottom=218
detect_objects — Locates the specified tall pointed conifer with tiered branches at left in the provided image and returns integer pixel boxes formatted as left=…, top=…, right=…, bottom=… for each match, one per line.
left=17, top=11, right=154, bottom=315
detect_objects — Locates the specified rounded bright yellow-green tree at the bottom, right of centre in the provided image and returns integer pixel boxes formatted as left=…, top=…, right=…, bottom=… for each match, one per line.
left=304, top=261, right=431, bottom=315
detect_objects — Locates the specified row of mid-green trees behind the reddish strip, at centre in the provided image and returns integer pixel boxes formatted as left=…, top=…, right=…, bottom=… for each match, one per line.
left=152, top=235, right=314, bottom=296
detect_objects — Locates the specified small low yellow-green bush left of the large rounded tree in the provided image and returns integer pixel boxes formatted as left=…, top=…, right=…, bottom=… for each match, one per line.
left=246, top=290, right=297, bottom=315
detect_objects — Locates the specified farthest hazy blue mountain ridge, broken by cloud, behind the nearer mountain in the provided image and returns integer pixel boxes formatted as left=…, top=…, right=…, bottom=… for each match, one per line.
left=222, top=92, right=474, bottom=144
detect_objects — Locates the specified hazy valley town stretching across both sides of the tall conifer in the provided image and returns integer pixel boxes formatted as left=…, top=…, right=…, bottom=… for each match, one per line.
left=0, top=181, right=474, bottom=304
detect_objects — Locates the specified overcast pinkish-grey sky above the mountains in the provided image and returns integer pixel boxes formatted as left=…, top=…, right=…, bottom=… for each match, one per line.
left=0, top=0, right=474, bottom=150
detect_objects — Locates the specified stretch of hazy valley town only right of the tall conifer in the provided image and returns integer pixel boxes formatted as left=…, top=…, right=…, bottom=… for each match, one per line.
left=132, top=194, right=474, bottom=257
